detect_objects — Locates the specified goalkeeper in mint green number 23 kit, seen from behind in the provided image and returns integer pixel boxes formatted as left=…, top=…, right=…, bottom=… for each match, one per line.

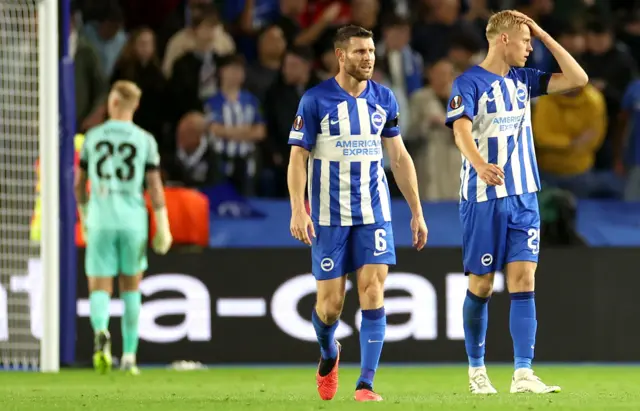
left=75, top=81, right=172, bottom=375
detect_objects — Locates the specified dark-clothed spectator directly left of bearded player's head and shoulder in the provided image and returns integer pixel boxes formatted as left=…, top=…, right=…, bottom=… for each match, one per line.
left=262, top=47, right=319, bottom=197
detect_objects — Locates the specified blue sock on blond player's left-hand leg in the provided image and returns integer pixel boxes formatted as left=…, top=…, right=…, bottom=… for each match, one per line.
left=462, top=290, right=490, bottom=367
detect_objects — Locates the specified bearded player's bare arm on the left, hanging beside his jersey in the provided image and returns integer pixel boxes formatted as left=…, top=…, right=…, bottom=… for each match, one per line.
left=287, top=146, right=316, bottom=245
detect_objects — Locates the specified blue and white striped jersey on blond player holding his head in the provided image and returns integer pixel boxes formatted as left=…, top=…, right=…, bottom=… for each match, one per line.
left=446, top=66, right=551, bottom=202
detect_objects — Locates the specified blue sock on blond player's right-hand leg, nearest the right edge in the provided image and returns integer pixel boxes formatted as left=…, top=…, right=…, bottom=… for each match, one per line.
left=509, top=291, right=538, bottom=370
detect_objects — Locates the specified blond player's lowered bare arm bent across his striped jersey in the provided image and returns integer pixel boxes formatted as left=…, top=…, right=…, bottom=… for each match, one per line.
left=453, top=117, right=504, bottom=186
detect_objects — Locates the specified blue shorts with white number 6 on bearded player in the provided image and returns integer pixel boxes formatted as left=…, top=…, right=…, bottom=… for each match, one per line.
left=311, top=222, right=396, bottom=281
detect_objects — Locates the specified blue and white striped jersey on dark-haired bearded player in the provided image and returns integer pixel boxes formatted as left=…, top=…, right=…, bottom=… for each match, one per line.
left=289, top=78, right=400, bottom=226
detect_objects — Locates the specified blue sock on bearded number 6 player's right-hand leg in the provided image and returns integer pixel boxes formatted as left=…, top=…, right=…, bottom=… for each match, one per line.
left=356, top=307, right=387, bottom=389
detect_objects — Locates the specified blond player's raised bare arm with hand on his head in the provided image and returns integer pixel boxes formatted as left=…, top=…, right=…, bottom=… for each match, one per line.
left=514, top=12, right=589, bottom=94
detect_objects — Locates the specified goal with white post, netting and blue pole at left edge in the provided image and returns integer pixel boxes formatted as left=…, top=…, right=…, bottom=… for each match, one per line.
left=0, top=0, right=77, bottom=372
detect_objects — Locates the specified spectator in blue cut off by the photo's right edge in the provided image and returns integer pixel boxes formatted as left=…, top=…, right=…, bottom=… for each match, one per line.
left=614, top=80, right=640, bottom=201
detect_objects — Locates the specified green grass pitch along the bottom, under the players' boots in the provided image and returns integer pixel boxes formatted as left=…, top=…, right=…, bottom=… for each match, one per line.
left=0, top=365, right=640, bottom=411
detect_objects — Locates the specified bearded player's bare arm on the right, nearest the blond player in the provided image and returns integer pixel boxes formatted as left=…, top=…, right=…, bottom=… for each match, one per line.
left=383, top=136, right=429, bottom=250
